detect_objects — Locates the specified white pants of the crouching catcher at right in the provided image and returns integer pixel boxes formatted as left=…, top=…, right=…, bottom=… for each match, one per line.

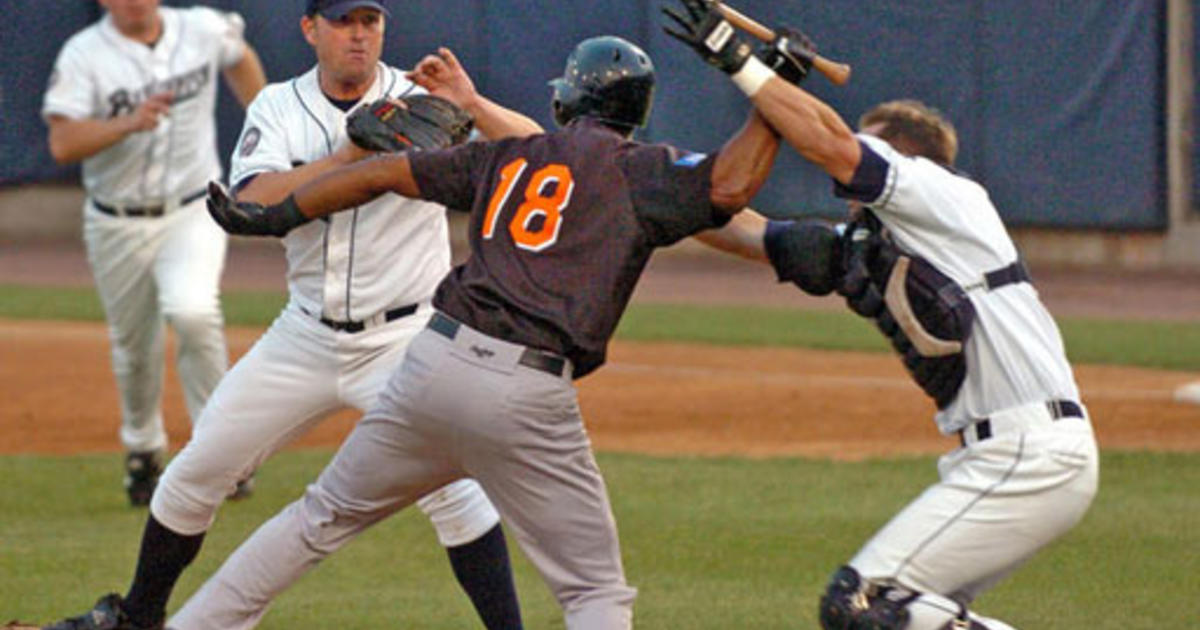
left=850, top=418, right=1099, bottom=630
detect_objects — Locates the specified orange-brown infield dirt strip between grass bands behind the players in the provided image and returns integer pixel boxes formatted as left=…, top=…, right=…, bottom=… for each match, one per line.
left=0, top=320, right=1200, bottom=458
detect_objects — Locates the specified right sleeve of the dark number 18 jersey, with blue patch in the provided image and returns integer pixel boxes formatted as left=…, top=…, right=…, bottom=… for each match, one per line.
left=620, top=144, right=730, bottom=247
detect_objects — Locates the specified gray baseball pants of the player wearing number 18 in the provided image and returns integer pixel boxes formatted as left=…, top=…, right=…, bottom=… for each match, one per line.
left=169, top=314, right=636, bottom=630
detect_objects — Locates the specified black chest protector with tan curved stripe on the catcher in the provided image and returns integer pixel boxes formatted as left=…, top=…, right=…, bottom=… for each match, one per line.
left=838, top=210, right=979, bottom=409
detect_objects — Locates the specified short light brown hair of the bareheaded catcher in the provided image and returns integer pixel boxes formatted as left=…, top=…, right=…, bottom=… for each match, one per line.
left=858, top=98, right=959, bottom=166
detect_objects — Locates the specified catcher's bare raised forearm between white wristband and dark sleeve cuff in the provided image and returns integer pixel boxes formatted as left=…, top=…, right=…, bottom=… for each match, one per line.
left=751, top=77, right=862, bottom=184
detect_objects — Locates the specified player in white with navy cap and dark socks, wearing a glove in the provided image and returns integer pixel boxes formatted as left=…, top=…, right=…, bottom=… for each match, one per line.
left=41, top=0, right=540, bottom=630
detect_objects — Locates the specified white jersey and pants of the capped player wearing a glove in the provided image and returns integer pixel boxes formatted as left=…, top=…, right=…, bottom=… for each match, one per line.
left=150, top=64, right=499, bottom=630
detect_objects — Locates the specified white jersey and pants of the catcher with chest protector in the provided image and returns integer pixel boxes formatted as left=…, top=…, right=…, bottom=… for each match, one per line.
left=839, top=134, right=1099, bottom=630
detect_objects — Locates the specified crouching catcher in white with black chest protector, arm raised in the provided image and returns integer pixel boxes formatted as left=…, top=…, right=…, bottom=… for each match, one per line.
left=672, top=0, right=1099, bottom=630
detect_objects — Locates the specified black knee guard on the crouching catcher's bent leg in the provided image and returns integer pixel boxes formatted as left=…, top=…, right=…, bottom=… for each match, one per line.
left=818, top=566, right=919, bottom=630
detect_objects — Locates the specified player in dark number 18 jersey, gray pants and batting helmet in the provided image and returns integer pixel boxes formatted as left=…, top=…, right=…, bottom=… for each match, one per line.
left=189, top=37, right=778, bottom=630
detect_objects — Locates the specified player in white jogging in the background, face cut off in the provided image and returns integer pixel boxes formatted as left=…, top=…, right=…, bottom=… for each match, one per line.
left=42, top=0, right=265, bottom=505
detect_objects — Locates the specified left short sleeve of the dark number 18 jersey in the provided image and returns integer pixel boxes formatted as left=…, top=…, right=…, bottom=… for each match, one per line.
left=408, top=142, right=491, bottom=212
